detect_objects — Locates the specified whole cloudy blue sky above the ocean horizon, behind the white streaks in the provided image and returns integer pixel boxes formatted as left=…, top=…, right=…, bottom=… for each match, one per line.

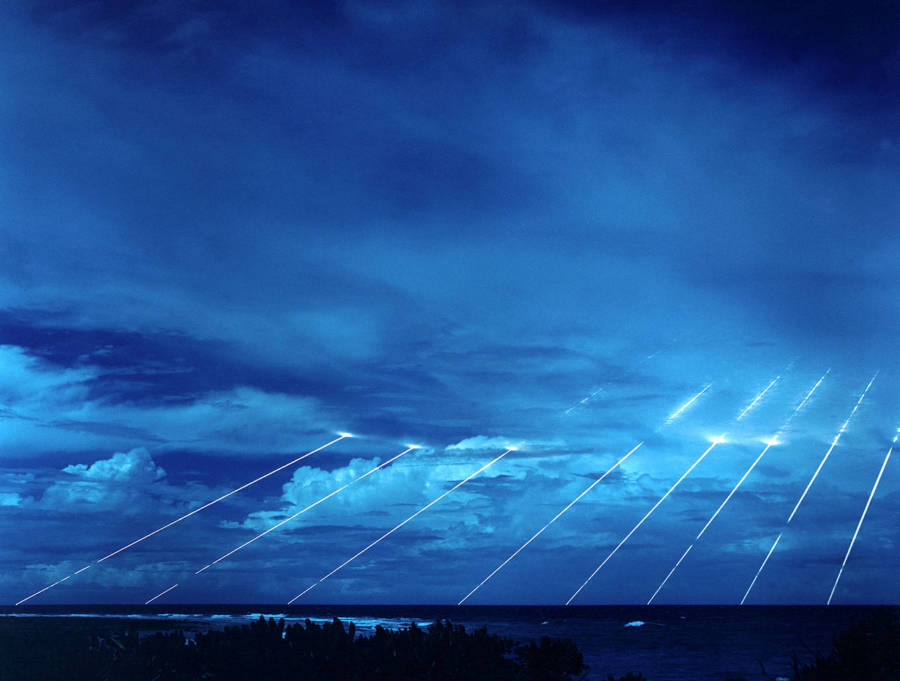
left=0, top=2, right=900, bottom=604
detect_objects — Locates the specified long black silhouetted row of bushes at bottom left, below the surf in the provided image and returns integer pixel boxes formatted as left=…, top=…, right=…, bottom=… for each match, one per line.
left=0, top=617, right=600, bottom=681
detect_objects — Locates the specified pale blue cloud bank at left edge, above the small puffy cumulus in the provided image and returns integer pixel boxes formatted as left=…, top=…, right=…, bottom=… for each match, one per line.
left=0, top=346, right=327, bottom=453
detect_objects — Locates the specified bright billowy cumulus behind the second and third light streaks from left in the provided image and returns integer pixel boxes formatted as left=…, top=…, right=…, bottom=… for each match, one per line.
left=228, top=438, right=620, bottom=558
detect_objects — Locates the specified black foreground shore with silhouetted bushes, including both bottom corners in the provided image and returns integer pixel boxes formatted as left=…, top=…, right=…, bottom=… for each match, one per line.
left=0, top=608, right=900, bottom=681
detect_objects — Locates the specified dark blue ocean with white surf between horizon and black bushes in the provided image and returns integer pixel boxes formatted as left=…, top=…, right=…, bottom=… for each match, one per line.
left=0, top=605, right=884, bottom=681
